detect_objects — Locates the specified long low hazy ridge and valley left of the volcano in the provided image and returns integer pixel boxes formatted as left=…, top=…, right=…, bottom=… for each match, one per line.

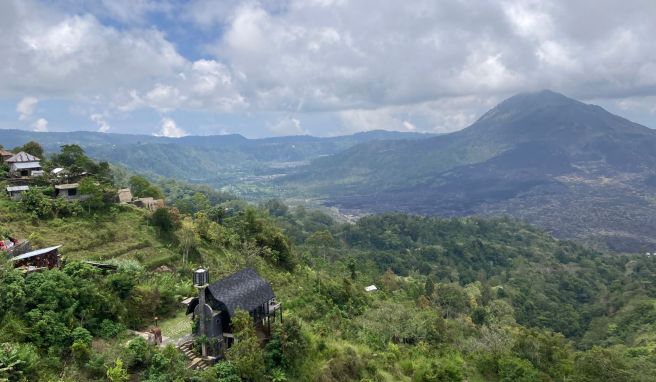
left=0, top=130, right=431, bottom=198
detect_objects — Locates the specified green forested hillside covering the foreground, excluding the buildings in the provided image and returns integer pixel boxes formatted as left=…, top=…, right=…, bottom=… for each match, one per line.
left=0, top=142, right=656, bottom=382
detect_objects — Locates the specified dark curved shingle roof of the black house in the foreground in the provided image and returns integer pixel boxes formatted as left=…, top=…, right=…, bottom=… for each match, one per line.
left=207, top=268, right=276, bottom=316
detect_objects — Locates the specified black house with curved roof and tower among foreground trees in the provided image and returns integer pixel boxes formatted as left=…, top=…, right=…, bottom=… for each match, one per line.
left=185, top=268, right=282, bottom=356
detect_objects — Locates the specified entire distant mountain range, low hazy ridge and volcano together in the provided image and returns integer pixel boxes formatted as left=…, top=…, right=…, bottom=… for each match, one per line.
left=0, top=91, right=656, bottom=252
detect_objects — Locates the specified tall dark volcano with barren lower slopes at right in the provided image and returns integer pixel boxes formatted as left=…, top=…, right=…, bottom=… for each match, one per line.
left=281, top=90, right=656, bottom=251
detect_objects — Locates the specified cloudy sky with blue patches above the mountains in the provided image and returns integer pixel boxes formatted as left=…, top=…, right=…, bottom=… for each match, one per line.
left=0, top=0, right=656, bottom=138
